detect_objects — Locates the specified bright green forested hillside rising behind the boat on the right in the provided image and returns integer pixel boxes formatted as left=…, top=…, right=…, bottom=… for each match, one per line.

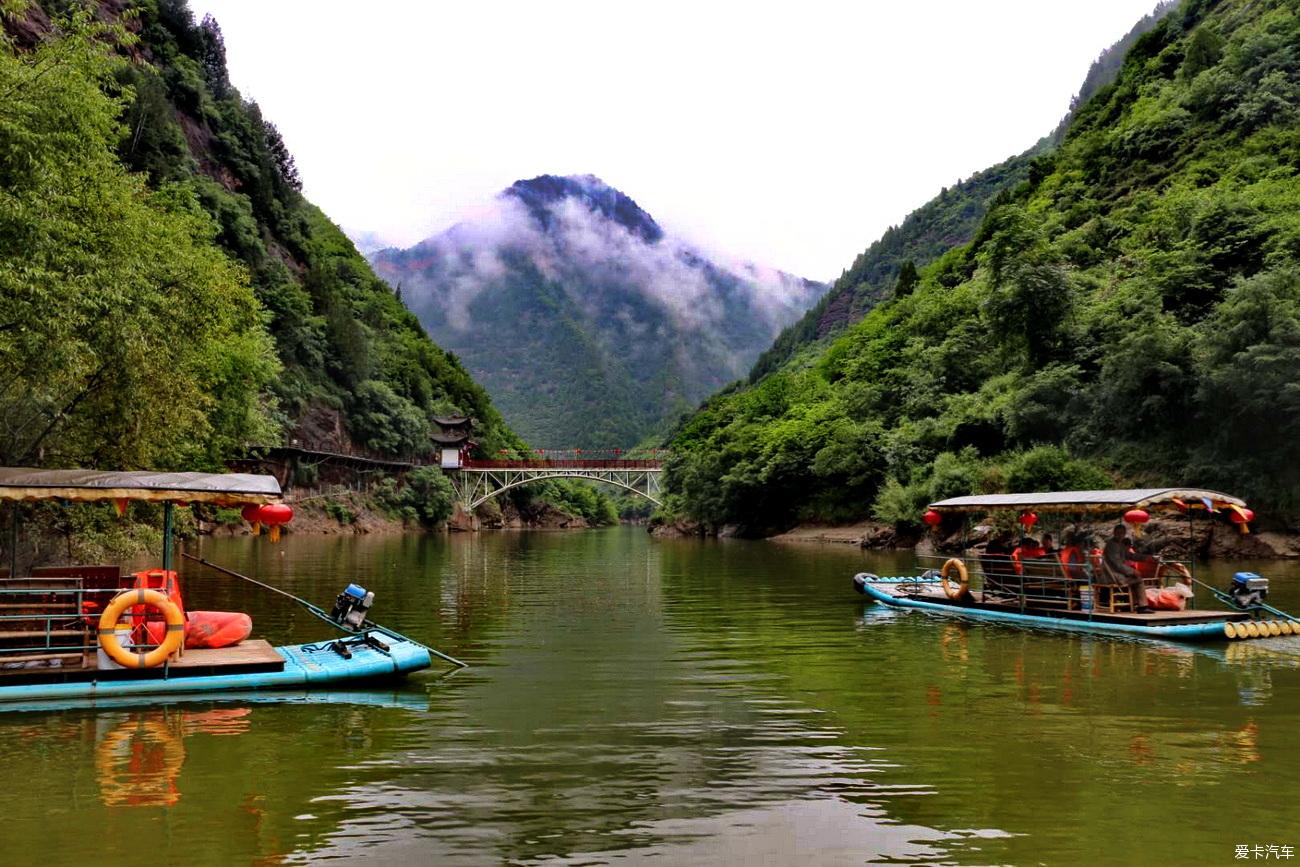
left=668, top=0, right=1300, bottom=532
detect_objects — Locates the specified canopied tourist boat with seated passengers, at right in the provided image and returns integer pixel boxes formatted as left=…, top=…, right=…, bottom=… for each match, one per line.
left=853, top=487, right=1300, bottom=642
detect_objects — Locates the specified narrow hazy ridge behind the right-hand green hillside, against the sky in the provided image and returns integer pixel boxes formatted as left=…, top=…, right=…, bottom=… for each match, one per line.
left=749, top=0, right=1175, bottom=383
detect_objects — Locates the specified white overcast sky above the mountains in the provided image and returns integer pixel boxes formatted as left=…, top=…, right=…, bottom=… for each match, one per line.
left=191, top=0, right=1156, bottom=279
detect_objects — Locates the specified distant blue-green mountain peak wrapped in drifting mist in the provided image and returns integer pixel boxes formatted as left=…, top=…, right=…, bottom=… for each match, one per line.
left=372, top=175, right=826, bottom=448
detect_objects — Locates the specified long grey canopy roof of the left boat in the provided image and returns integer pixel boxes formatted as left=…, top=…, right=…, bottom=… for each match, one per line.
left=0, top=467, right=281, bottom=506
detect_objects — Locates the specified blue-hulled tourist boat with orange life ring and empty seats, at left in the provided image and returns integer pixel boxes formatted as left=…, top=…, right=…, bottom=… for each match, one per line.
left=0, top=468, right=464, bottom=708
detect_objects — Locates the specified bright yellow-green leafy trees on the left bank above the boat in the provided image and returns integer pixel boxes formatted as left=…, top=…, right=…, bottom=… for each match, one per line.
left=0, top=13, right=277, bottom=467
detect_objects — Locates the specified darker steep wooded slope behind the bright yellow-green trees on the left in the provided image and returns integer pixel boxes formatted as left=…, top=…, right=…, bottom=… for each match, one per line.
left=120, top=0, right=521, bottom=454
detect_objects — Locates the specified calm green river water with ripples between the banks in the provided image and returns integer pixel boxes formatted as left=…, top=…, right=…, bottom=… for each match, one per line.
left=0, top=528, right=1300, bottom=867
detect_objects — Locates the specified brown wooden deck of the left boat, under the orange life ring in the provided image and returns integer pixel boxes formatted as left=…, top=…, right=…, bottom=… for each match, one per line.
left=0, top=638, right=285, bottom=686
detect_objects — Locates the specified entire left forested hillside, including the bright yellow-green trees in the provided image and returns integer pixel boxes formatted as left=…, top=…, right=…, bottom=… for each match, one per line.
left=0, top=0, right=523, bottom=469
